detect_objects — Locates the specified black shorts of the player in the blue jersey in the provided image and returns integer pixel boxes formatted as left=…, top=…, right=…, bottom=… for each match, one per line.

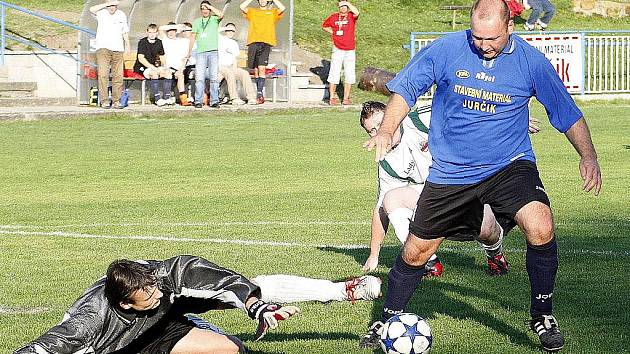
left=409, top=160, right=551, bottom=241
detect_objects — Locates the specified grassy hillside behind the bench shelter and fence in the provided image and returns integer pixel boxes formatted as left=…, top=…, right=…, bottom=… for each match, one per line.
left=3, top=0, right=630, bottom=98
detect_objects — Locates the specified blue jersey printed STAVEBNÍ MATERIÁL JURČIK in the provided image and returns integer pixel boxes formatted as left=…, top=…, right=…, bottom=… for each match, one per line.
left=387, top=30, right=582, bottom=184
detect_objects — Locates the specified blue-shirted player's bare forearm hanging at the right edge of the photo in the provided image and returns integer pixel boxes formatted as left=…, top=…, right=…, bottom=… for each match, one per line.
left=564, top=117, right=602, bottom=195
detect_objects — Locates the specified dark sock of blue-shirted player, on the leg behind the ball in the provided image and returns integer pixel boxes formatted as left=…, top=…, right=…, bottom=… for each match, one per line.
left=383, top=255, right=426, bottom=322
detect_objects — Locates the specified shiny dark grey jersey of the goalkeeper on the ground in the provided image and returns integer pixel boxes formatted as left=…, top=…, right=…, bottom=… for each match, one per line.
left=15, top=256, right=260, bottom=354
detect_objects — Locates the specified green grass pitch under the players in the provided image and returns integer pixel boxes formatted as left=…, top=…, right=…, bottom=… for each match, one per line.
left=0, top=102, right=630, bottom=353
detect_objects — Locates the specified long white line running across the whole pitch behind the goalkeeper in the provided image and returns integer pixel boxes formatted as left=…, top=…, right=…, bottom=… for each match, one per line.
left=0, top=230, right=630, bottom=257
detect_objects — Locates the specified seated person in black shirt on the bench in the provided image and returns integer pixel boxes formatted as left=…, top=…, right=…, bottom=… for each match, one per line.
left=133, top=23, right=175, bottom=107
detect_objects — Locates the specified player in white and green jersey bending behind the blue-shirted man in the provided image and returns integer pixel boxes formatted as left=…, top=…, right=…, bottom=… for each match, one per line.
left=361, top=101, right=508, bottom=276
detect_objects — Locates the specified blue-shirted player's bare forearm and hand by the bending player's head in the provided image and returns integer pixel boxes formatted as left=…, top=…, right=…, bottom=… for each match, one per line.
left=363, top=93, right=409, bottom=161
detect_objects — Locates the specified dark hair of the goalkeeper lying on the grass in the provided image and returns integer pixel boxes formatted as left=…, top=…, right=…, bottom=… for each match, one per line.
left=105, top=259, right=156, bottom=306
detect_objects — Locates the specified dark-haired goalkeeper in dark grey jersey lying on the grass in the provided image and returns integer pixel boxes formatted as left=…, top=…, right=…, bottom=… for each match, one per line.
left=15, top=256, right=381, bottom=354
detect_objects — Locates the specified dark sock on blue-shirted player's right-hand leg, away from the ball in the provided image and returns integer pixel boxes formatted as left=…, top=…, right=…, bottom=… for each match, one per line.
left=525, top=236, right=558, bottom=317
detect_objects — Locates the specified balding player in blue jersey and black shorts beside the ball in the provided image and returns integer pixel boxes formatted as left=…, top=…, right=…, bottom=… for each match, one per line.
left=360, top=0, right=602, bottom=351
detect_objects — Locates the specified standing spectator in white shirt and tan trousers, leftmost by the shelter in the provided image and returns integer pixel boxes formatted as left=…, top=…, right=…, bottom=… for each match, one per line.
left=90, top=0, right=131, bottom=109
